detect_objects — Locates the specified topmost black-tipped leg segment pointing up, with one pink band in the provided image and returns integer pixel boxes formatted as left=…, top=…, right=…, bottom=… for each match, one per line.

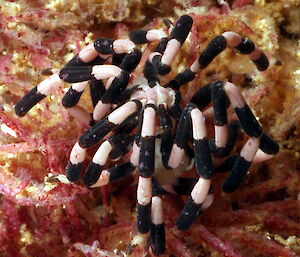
left=150, top=15, right=193, bottom=75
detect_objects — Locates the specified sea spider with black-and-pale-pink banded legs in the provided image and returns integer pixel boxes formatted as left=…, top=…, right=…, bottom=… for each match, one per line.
left=15, top=15, right=279, bottom=255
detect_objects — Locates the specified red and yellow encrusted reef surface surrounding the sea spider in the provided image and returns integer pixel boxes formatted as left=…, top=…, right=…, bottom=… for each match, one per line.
left=0, top=0, right=300, bottom=257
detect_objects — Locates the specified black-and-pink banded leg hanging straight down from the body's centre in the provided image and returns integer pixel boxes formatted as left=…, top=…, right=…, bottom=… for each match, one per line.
left=137, top=101, right=156, bottom=234
